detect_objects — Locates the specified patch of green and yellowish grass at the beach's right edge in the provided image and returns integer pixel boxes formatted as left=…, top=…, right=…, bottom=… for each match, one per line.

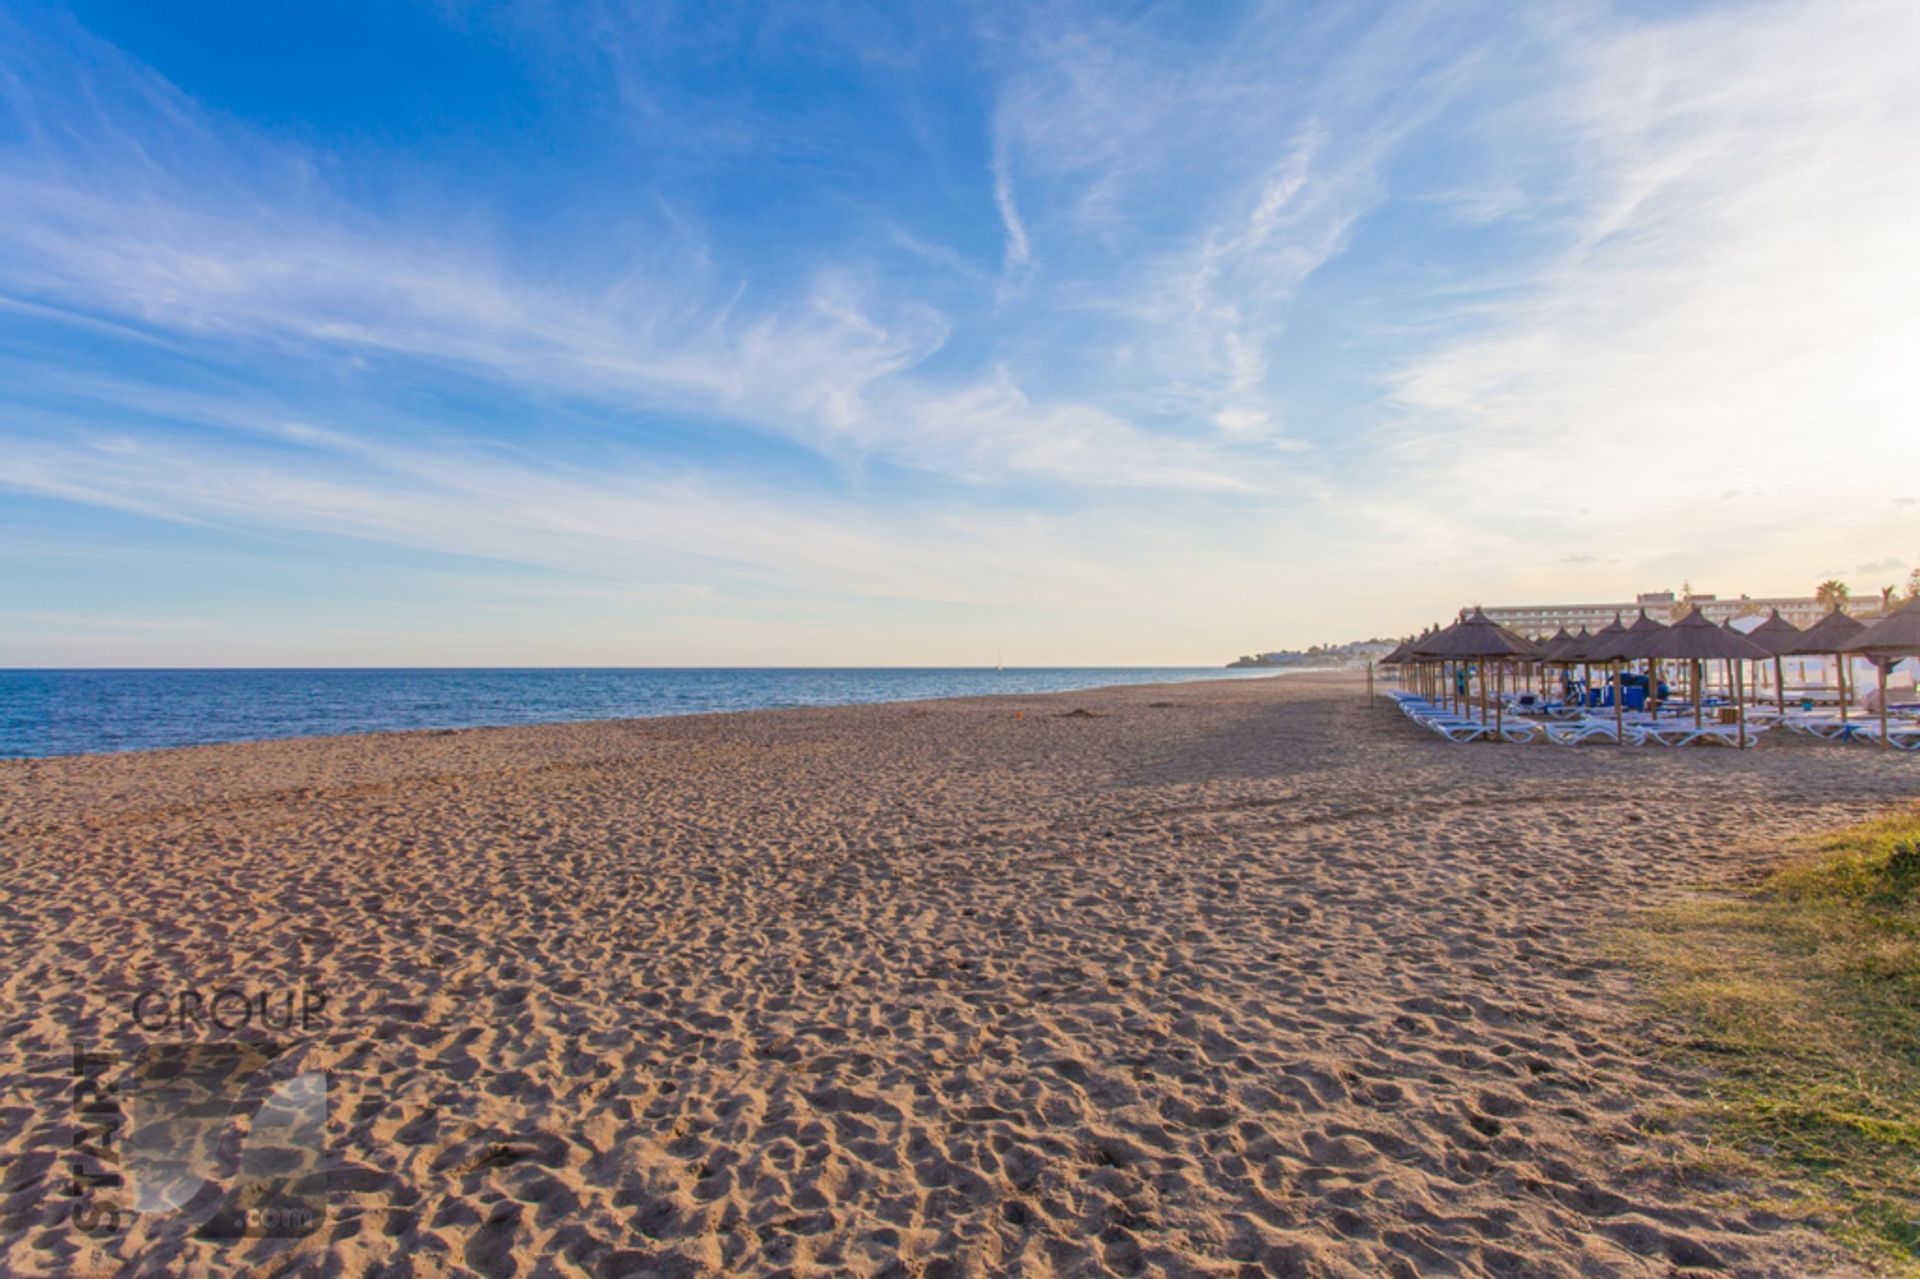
left=1630, top=810, right=1920, bottom=1275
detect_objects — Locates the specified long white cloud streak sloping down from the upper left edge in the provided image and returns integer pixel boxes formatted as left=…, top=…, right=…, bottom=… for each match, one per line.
left=0, top=16, right=1267, bottom=488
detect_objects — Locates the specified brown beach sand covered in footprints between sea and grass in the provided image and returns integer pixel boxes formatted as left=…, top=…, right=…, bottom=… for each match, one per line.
left=0, top=676, right=1920, bottom=1275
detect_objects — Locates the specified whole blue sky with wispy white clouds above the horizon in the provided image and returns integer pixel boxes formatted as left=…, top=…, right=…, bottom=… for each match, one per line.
left=0, top=0, right=1920, bottom=664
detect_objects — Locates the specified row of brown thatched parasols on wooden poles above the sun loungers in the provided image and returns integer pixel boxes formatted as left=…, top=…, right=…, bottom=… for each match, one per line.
left=1380, top=597, right=1920, bottom=745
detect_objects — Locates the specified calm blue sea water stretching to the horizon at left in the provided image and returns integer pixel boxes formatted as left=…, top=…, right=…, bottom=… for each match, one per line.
left=0, top=666, right=1273, bottom=759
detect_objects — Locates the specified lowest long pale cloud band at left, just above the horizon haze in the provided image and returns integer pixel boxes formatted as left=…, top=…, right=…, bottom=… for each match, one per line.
left=8, top=409, right=1089, bottom=603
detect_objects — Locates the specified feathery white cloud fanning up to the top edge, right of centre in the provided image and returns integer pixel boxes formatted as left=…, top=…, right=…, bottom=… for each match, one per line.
left=995, top=4, right=1475, bottom=434
